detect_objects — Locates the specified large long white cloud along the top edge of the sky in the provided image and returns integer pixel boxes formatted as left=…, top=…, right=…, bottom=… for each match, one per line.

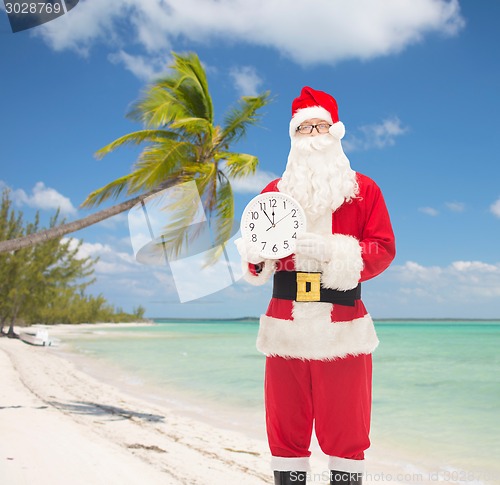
left=35, top=0, right=465, bottom=72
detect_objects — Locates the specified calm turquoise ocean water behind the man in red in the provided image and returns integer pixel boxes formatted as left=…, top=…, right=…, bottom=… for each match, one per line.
left=59, top=320, right=500, bottom=484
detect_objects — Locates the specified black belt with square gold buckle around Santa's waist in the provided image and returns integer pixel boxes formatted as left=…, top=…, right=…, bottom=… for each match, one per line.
left=273, top=271, right=361, bottom=306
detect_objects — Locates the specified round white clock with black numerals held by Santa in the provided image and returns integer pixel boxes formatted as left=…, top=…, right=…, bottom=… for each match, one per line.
left=241, top=192, right=306, bottom=259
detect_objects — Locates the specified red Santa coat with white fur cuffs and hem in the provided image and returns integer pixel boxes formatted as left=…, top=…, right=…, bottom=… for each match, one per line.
left=245, top=173, right=396, bottom=360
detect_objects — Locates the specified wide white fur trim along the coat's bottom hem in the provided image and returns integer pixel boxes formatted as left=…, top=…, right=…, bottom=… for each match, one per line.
left=257, top=310, right=379, bottom=360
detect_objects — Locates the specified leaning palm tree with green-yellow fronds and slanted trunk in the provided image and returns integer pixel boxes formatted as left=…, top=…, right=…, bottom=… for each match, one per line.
left=0, top=53, right=269, bottom=258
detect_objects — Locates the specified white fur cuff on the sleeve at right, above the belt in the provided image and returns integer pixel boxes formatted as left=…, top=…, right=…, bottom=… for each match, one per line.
left=321, top=234, right=364, bottom=291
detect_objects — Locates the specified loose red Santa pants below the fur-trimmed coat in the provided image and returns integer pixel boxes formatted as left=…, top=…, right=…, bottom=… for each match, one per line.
left=265, top=354, right=372, bottom=471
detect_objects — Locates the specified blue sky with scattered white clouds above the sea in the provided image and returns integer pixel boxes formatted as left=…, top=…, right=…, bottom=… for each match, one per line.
left=0, top=0, right=500, bottom=319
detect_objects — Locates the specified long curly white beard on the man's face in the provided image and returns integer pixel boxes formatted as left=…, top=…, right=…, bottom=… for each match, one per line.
left=278, top=134, right=359, bottom=222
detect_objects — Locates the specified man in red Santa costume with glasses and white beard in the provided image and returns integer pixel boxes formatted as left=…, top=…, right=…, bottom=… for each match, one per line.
left=237, top=86, right=395, bottom=485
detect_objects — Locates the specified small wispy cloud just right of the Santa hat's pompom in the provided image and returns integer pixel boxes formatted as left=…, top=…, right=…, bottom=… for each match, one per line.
left=342, top=116, right=408, bottom=152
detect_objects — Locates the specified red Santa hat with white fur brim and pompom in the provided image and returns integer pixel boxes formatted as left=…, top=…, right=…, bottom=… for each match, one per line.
left=290, top=86, right=345, bottom=140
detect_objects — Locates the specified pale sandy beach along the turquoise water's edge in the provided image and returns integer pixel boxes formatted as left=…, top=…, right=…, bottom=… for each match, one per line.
left=0, top=325, right=478, bottom=485
